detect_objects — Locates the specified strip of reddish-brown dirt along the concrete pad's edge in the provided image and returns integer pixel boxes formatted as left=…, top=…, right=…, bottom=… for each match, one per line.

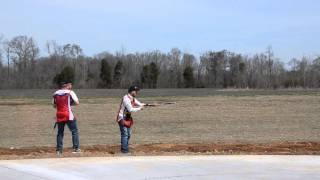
left=0, top=142, right=320, bottom=159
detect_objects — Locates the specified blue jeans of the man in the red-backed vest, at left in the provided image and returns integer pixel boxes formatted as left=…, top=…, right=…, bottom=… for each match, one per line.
left=56, top=120, right=79, bottom=151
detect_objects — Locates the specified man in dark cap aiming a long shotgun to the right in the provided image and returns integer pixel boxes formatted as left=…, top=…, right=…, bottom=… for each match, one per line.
left=117, top=86, right=146, bottom=154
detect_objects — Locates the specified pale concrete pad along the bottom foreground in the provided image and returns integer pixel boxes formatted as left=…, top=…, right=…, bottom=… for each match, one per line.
left=0, top=155, right=320, bottom=180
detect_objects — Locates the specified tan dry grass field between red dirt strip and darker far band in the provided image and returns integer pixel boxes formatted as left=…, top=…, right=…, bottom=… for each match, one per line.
left=0, top=90, right=320, bottom=147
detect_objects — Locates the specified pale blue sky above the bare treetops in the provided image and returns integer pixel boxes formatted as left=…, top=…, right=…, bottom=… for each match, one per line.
left=0, top=0, right=320, bottom=62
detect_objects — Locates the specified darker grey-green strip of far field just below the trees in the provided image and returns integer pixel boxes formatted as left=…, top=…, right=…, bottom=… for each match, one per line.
left=0, top=88, right=320, bottom=100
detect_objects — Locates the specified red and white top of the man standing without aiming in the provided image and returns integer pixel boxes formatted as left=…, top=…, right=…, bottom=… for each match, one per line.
left=52, top=89, right=79, bottom=122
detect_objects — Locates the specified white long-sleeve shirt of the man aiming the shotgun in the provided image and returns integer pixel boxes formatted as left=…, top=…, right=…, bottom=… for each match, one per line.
left=117, top=94, right=143, bottom=121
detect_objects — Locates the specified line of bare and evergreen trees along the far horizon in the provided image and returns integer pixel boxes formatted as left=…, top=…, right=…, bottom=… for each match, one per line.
left=0, top=36, right=320, bottom=89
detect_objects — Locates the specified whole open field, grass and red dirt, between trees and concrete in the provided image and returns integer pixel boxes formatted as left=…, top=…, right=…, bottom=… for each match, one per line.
left=0, top=89, right=320, bottom=159
